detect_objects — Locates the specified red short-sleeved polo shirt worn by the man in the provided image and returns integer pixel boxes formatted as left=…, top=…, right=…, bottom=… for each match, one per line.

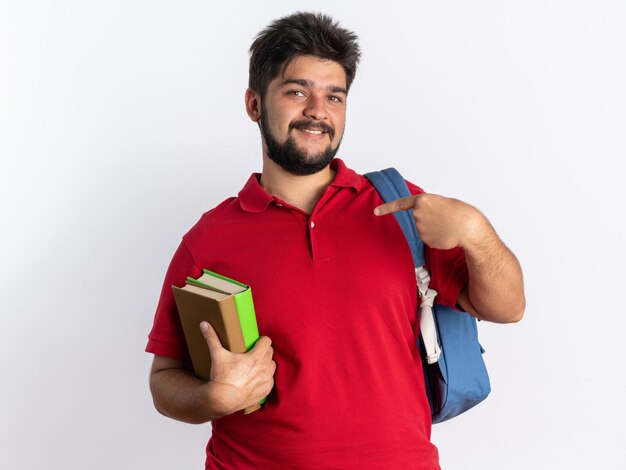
left=146, top=159, right=467, bottom=470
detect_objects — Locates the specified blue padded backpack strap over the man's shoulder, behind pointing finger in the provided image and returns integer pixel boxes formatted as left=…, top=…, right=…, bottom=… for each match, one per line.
left=364, top=168, right=425, bottom=268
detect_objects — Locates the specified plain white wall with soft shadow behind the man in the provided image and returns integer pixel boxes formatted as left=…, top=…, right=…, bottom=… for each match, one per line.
left=0, top=0, right=626, bottom=470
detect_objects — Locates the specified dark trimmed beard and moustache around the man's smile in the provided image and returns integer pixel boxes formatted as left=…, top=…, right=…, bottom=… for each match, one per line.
left=259, top=110, right=341, bottom=176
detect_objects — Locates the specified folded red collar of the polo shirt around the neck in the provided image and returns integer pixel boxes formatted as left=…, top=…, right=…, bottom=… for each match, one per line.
left=238, top=158, right=361, bottom=212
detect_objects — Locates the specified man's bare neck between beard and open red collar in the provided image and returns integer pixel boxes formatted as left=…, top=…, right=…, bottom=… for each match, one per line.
left=261, top=155, right=335, bottom=214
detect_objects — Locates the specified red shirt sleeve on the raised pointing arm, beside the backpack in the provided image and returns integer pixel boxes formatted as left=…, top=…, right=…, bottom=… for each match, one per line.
left=407, top=181, right=469, bottom=308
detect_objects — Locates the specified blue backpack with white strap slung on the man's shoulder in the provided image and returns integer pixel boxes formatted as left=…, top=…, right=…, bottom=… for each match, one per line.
left=365, top=168, right=491, bottom=423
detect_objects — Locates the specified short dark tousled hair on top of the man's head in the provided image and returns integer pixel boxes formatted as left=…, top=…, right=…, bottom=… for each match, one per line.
left=248, top=11, right=361, bottom=96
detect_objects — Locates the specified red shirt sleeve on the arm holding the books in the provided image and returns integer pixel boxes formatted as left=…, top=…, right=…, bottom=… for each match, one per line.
left=146, top=241, right=202, bottom=360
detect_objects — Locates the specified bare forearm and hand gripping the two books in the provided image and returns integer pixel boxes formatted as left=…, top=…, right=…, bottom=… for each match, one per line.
left=150, top=323, right=276, bottom=424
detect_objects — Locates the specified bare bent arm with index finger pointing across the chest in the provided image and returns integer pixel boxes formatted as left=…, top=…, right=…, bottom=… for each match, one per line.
left=374, top=194, right=526, bottom=323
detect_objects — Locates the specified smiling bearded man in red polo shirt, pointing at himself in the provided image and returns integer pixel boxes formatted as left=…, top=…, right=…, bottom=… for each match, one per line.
left=147, top=13, right=524, bottom=470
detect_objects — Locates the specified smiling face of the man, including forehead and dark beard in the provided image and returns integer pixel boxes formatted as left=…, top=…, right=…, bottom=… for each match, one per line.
left=259, top=56, right=347, bottom=175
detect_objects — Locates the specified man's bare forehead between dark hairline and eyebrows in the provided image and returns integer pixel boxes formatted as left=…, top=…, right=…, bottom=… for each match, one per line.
left=272, top=55, right=347, bottom=88
